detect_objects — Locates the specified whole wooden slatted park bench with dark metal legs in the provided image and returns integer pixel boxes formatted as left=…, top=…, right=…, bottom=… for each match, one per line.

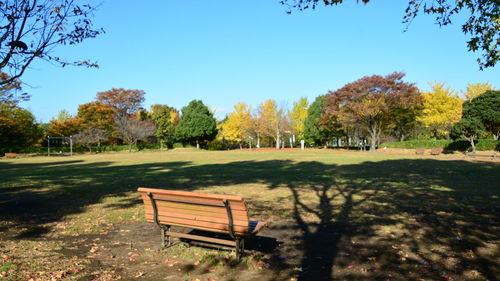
left=138, top=187, right=268, bottom=260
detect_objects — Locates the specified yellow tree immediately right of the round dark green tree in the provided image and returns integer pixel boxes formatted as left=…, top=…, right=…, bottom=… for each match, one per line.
left=221, top=102, right=252, bottom=148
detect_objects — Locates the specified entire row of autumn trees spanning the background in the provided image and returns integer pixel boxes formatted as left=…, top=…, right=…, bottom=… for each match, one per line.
left=0, top=72, right=500, bottom=153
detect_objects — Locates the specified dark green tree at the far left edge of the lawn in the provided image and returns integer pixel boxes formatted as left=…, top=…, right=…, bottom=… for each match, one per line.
left=0, top=104, right=42, bottom=153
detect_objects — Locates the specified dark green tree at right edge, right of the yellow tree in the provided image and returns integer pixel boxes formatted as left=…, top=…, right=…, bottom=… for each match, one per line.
left=462, top=91, right=500, bottom=139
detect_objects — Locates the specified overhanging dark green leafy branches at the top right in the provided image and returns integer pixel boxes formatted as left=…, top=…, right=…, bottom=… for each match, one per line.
left=281, top=0, right=500, bottom=69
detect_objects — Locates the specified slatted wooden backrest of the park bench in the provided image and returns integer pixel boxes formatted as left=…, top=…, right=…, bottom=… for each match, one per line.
left=138, top=187, right=249, bottom=235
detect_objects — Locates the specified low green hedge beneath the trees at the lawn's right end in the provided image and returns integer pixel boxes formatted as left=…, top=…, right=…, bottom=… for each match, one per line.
left=380, top=139, right=500, bottom=151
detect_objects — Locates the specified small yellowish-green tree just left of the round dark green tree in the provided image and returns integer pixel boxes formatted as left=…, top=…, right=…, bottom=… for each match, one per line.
left=149, top=104, right=179, bottom=148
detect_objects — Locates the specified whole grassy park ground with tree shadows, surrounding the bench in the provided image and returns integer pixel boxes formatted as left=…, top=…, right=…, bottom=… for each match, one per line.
left=0, top=150, right=500, bottom=280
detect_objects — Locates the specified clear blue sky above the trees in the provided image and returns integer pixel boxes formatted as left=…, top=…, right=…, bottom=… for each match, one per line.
left=21, top=0, right=500, bottom=122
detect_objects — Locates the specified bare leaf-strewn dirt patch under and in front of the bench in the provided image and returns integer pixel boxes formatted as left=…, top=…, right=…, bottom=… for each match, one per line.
left=54, top=222, right=300, bottom=281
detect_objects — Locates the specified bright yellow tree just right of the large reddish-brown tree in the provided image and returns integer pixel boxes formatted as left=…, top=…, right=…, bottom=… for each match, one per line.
left=418, top=82, right=463, bottom=138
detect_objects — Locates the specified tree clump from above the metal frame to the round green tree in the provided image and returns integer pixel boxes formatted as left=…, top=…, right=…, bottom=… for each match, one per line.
left=45, top=89, right=217, bottom=151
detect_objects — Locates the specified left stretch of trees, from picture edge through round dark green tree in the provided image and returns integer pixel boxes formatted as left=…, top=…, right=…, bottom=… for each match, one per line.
left=0, top=71, right=217, bottom=152
